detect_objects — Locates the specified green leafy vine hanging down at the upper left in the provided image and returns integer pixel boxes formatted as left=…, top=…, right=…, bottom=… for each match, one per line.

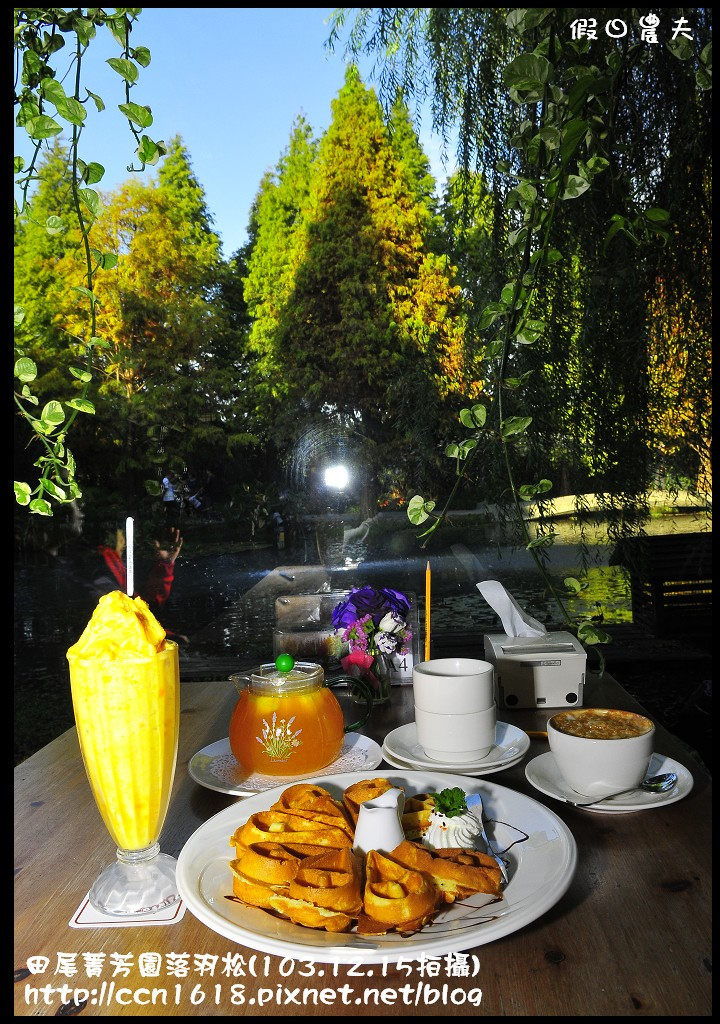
left=14, top=7, right=166, bottom=516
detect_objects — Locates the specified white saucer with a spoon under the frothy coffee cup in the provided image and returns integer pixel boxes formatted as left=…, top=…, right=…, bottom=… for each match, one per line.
left=525, top=751, right=692, bottom=814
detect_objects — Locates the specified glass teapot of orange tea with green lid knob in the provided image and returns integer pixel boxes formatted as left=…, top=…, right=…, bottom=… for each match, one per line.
left=229, top=654, right=373, bottom=776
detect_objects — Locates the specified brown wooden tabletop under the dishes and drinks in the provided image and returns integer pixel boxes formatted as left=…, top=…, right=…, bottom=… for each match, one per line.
left=14, top=675, right=712, bottom=1017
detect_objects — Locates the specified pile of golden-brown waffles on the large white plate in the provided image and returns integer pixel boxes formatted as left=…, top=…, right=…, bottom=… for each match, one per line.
left=229, top=778, right=510, bottom=935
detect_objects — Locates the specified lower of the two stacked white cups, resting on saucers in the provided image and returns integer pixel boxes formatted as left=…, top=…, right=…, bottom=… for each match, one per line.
left=415, top=705, right=497, bottom=764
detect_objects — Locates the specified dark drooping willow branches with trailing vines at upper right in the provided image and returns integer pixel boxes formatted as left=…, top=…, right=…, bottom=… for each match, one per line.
left=331, top=8, right=712, bottom=642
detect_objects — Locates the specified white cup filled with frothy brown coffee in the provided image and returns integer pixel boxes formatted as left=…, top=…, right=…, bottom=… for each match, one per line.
left=548, top=708, right=655, bottom=800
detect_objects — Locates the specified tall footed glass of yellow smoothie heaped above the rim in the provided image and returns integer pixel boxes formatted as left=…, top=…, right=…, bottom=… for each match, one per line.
left=68, top=591, right=180, bottom=915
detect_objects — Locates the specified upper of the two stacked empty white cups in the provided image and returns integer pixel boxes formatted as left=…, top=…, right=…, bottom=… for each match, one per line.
left=413, top=657, right=495, bottom=715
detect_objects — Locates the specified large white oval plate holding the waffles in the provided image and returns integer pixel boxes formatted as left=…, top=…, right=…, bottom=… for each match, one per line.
left=177, top=771, right=578, bottom=964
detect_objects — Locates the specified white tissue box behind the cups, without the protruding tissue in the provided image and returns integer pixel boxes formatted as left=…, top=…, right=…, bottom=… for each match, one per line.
left=484, top=632, right=588, bottom=709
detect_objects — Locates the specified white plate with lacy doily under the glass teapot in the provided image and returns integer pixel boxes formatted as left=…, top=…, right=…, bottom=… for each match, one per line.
left=187, top=732, right=382, bottom=797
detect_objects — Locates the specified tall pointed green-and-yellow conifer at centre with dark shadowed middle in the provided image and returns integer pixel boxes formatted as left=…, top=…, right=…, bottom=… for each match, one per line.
left=244, top=68, right=472, bottom=513
